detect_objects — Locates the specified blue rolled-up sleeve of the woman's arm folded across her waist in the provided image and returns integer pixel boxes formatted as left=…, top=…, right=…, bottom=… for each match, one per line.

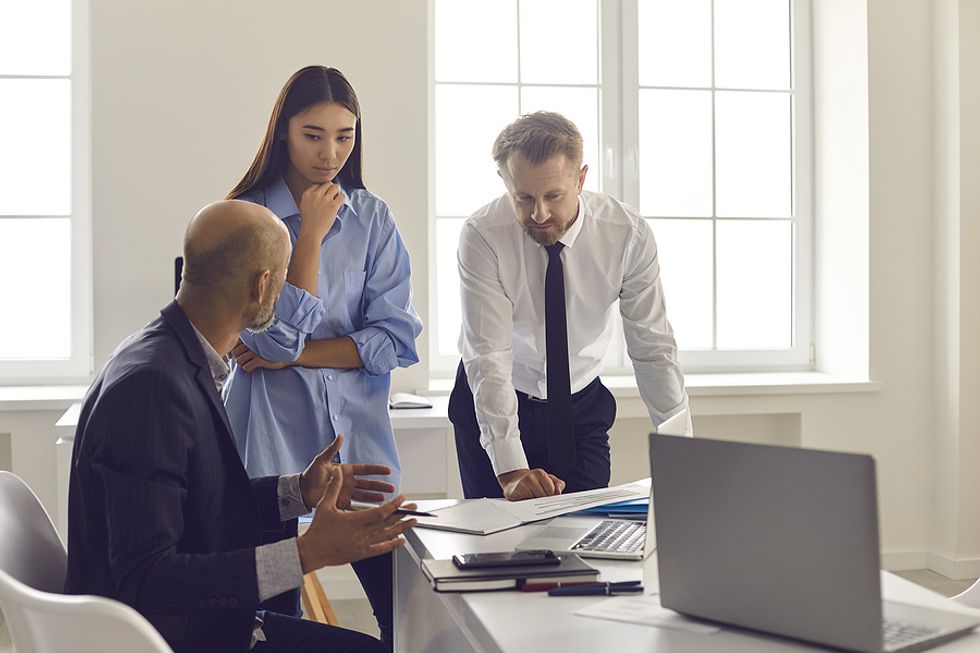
left=350, top=208, right=422, bottom=375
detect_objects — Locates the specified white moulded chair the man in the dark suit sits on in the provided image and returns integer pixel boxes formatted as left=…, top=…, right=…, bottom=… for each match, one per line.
left=0, top=472, right=172, bottom=653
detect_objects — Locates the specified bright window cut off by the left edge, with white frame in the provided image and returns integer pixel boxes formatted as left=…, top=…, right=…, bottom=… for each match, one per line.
left=0, top=0, right=91, bottom=383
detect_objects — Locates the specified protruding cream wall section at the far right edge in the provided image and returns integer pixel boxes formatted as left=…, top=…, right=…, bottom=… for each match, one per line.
left=932, top=0, right=980, bottom=574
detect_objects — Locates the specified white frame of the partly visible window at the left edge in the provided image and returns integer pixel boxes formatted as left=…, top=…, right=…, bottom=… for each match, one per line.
left=0, top=0, right=94, bottom=385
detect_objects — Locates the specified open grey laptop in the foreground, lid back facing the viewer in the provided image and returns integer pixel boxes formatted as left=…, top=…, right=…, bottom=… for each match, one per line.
left=650, top=435, right=980, bottom=653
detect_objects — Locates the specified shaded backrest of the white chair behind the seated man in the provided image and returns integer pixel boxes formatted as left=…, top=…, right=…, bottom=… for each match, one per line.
left=0, top=472, right=68, bottom=594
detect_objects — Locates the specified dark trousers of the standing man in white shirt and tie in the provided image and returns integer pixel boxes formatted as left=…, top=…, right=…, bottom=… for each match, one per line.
left=449, top=363, right=616, bottom=499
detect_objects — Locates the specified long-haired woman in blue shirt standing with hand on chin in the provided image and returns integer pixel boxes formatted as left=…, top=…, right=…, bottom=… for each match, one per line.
left=225, top=66, right=422, bottom=646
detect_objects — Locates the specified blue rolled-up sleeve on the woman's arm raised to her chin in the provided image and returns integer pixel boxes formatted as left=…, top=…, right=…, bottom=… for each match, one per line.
left=241, top=282, right=324, bottom=361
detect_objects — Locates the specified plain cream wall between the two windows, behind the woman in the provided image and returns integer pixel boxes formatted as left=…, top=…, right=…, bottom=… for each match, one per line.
left=92, top=0, right=428, bottom=388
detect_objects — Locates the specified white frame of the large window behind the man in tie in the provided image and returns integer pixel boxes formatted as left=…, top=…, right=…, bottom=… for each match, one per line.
left=428, top=0, right=815, bottom=379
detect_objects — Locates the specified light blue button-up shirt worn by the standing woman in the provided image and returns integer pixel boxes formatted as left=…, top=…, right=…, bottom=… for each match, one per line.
left=224, top=179, right=422, bottom=487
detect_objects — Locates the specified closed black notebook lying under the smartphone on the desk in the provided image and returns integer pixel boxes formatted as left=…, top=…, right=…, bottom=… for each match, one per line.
left=422, top=555, right=599, bottom=592
